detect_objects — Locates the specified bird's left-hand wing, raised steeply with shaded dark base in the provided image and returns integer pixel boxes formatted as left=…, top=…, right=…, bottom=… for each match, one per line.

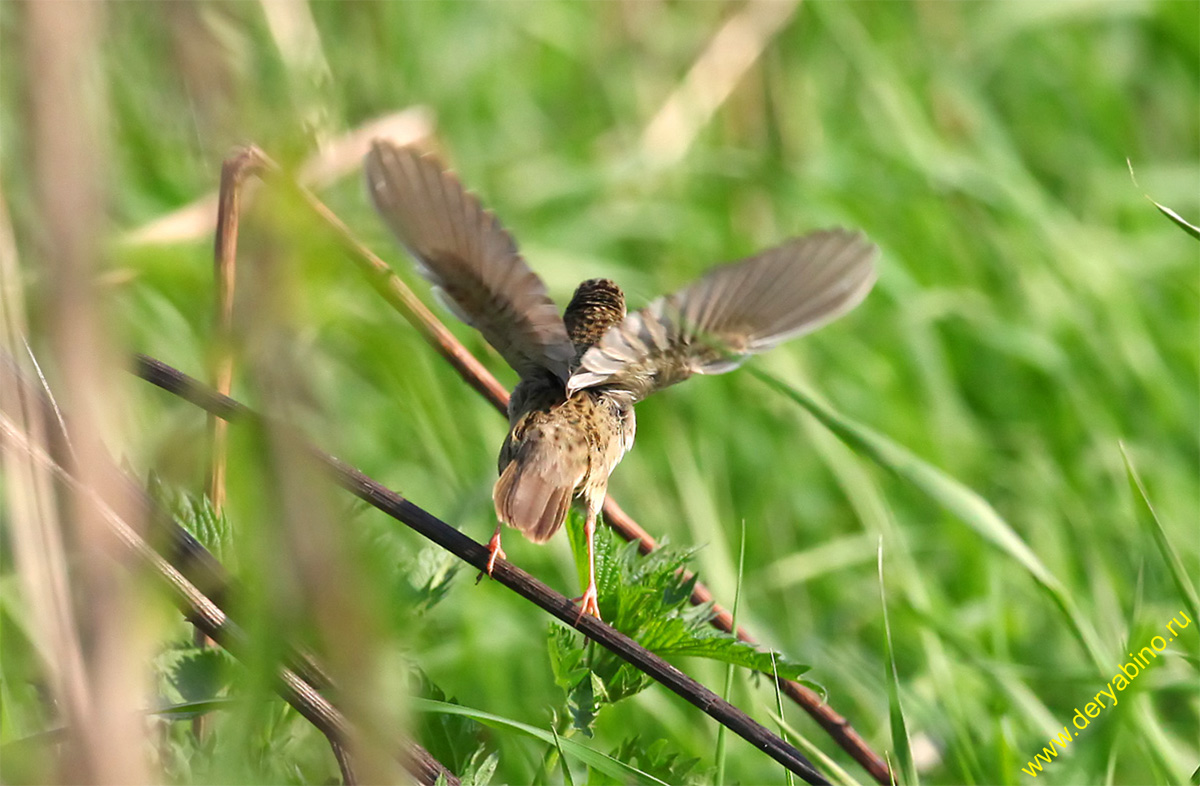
left=366, top=139, right=575, bottom=379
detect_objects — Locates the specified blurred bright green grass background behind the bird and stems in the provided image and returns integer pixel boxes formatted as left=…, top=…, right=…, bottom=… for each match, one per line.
left=0, top=0, right=1200, bottom=784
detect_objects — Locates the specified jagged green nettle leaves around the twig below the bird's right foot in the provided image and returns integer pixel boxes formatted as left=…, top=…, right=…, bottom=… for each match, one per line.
left=547, top=511, right=808, bottom=734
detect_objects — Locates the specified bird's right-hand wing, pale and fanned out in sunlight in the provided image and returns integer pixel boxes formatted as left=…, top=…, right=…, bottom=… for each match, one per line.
left=566, top=229, right=877, bottom=401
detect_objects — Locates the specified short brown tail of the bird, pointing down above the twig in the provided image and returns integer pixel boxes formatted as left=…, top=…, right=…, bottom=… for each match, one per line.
left=492, top=428, right=586, bottom=544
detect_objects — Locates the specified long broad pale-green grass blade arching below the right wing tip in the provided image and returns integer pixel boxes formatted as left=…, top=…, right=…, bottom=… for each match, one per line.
left=749, top=368, right=1110, bottom=676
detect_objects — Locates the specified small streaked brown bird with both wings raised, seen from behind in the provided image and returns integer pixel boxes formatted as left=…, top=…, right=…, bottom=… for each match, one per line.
left=366, top=140, right=876, bottom=617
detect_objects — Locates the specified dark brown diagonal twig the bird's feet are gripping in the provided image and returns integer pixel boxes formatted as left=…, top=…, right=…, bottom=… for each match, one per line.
left=129, top=355, right=828, bottom=784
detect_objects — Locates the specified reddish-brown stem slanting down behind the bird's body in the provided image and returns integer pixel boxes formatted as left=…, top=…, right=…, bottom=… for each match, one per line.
left=236, top=148, right=892, bottom=785
